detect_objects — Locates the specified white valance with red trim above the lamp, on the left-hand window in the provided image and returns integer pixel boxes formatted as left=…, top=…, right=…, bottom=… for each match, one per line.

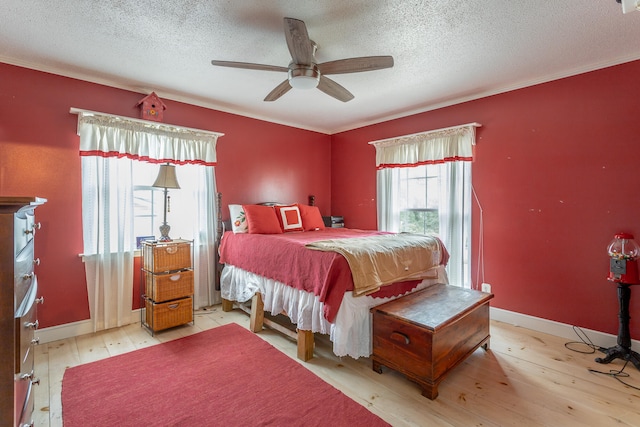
left=71, top=108, right=223, bottom=166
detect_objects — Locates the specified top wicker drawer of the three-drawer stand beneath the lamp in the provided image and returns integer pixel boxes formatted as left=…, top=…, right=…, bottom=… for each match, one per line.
left=142, top=240, right=191, bottom=273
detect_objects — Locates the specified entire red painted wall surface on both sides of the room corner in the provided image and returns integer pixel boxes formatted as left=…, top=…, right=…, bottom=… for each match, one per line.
left=5, top=61, right=640, bottom=339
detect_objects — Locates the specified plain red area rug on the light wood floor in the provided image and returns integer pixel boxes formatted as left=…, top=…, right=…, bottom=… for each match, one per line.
left=62, top=323, right=389, bottom=427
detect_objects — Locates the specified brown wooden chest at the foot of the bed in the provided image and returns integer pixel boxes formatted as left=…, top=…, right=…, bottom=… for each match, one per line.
left=371, top=284, right=493, bottom=399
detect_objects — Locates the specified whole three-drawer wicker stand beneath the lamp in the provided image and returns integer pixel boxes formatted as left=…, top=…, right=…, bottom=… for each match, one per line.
left=141, top=240, right=193, bottom=334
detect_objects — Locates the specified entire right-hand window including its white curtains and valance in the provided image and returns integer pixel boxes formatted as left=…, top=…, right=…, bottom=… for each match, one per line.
left=370, top=123, right=480, bottom=288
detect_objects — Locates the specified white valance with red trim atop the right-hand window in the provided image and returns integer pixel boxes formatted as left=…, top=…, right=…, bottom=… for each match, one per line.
left=369, top=123, right=481, bottom=169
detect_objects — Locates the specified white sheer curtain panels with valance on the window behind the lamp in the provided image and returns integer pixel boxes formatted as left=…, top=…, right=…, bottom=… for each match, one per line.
left=72, top=109, right=221, bottom=331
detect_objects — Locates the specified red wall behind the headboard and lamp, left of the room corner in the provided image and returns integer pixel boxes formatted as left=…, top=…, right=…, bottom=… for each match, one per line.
left=0, top=64, right=331, bottom=327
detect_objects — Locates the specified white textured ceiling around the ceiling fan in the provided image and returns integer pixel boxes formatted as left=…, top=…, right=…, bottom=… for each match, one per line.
left=0, top=0, right=640, bottom=134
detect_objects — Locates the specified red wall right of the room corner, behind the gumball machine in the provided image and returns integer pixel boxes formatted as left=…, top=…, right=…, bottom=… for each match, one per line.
left=331, top=61, right=640, bottom=339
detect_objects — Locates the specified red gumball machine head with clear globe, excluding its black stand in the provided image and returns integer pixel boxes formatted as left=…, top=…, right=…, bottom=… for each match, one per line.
left=607, top=233, right=640, bottom=285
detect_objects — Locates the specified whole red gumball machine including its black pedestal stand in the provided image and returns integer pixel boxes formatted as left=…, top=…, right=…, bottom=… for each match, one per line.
left=596, top=233, right=640, bottom=369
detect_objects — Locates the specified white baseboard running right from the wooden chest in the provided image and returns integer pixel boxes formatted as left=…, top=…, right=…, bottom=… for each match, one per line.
left=491, top=307, right=640, bottom=348
